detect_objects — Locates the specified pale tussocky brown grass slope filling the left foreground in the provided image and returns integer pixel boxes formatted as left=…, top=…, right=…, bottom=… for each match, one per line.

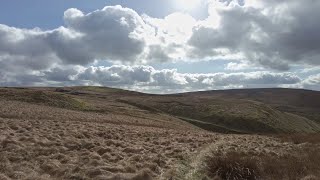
left=0, top=101, right=214, bottom=180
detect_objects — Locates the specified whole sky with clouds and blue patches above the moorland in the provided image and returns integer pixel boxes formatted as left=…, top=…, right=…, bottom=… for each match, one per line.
left=0, top=0, right=320, bottom=94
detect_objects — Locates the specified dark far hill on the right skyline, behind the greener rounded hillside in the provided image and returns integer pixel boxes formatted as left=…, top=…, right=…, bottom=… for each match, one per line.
left=183, top=88, right=320, bottom=123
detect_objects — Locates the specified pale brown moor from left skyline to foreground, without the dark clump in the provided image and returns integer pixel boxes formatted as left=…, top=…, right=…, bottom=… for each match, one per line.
left=0, top=87, right=320, bottom=180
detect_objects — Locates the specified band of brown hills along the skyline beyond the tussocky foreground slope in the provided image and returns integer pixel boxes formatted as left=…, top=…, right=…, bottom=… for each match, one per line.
left=0, top=87, right=320, bottom=134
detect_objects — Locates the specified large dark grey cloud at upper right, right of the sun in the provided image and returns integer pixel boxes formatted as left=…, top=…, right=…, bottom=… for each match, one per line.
left=189, top=0, right=320, bottom=70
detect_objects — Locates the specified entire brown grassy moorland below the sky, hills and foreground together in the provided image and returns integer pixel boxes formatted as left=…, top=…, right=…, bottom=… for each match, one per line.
left=0, top=87, right=320, bottom=180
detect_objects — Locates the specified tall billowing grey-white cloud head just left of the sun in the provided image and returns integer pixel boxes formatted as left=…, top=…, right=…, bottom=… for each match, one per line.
left=60, top=6, right=147, bottom=62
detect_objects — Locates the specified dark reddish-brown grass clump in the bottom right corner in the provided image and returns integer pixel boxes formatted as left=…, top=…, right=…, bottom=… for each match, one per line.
left=204, top=149, right=320, bottom=180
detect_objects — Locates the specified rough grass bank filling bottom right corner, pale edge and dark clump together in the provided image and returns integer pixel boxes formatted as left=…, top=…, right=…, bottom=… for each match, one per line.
left=167, top=134, right=320, bottom=180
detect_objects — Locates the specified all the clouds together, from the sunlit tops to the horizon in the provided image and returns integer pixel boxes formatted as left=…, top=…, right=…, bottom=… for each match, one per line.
left=0, top=0, right=320, bottom=91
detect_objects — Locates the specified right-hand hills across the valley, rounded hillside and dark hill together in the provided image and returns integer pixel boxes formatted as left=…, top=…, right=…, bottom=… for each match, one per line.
left=119, top=89, right=320, bottom=133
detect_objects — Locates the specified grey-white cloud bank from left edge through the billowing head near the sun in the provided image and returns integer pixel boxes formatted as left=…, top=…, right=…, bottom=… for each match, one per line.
left=0, top=6, right=147, bottom=69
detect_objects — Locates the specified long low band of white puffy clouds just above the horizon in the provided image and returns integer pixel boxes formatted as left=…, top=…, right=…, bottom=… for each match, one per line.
left=6, top=65, right=301, bottom=92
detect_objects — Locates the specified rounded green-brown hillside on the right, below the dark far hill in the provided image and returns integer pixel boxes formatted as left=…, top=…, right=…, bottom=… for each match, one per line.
left=119, top=96, right=320, bottom=133
